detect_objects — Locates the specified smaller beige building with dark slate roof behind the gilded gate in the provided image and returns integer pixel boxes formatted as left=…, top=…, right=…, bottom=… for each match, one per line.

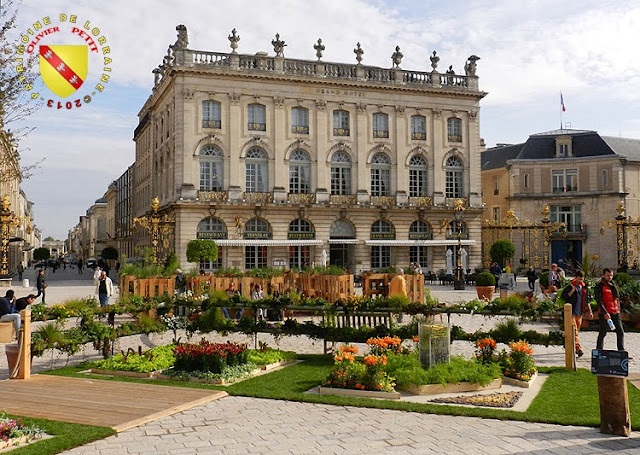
left=482, top=129, right=640, bottom=268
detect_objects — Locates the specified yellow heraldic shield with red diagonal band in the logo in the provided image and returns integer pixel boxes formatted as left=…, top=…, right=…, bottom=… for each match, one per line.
left=40, top=45, right=89, bottom=98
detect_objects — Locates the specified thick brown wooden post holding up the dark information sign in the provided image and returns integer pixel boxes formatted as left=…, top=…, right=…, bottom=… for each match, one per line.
left=598, top=375, right=631, bottom=436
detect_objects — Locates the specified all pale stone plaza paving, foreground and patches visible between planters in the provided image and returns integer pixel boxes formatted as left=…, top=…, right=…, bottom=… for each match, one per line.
left=0, top=270, right=640, bottom=455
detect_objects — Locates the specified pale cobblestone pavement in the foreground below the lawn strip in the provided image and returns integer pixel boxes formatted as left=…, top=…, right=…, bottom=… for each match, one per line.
left=66, top=397, right=640, bottom=455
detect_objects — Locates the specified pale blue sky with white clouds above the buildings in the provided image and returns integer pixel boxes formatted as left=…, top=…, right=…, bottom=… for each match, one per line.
left=1, top=0, right=640, bottom=239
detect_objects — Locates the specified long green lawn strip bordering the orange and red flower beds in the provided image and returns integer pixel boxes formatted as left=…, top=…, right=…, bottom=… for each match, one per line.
left=48, top=355, right=640, bottom=430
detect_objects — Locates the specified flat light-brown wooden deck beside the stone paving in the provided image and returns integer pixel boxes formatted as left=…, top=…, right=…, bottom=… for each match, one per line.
left=0, top=375, right=227, bottom=431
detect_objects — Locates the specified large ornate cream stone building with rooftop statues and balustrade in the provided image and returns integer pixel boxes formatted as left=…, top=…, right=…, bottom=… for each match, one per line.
left=131, top=25, right=486, bottom=273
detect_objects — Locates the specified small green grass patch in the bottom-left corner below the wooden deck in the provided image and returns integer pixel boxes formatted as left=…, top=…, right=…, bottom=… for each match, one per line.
left=7, top=415, right=115, bottom=455
